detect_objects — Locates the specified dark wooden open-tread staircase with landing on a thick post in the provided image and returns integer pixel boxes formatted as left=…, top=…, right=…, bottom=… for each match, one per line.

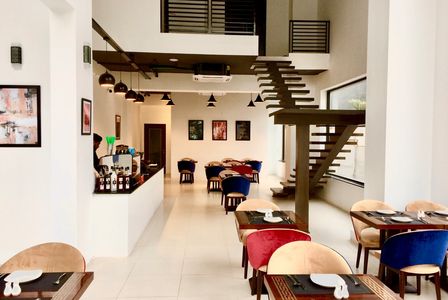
left=252, top=57, right=365, bottom=223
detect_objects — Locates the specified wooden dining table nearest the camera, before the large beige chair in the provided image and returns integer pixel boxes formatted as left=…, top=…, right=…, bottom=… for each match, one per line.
left=264, top=274, right=401, bottom=300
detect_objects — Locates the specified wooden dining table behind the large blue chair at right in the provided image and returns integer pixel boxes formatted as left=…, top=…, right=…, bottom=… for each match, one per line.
left=350, top=211, right=448, bottom=291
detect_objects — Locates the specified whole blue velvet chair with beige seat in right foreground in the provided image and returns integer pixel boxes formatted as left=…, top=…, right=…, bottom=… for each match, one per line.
left=378, top=230, right=448, bottom=300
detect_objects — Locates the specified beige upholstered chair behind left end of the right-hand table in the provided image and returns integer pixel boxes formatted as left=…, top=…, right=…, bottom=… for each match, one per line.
left=350, top=199, right=393, bottom=274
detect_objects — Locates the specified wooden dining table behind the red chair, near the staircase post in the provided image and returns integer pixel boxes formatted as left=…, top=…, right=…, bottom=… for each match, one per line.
left=235, top=210, right=308, bottom=232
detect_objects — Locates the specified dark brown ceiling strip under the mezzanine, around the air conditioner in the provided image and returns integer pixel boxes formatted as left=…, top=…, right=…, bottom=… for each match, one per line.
left=93, top=51, right=257, bottom=77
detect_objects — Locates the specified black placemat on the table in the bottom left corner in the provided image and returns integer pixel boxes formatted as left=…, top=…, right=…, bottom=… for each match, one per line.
left=0, top=272, right=73, bottom=292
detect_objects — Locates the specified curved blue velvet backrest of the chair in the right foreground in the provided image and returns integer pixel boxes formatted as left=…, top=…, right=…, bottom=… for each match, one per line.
left=380, top=229, right=448, bottom=270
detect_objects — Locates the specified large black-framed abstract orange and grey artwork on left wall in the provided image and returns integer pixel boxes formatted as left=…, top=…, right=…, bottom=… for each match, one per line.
left=0, top=85, right=41, bottom=147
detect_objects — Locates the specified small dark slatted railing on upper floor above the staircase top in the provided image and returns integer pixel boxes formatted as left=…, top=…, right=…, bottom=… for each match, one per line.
left=289, top=20, right=330, bottom=53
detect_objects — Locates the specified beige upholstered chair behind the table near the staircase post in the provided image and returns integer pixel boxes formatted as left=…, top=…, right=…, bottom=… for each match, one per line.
left=235, top=199, right=280, bottom=279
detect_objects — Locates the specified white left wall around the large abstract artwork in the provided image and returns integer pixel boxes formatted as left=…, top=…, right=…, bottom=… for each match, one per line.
left=0, top=0, right=93, bottom=261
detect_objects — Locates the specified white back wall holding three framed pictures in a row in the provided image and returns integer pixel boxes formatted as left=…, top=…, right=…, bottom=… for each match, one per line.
left=171, top=93, right=270, bottom=179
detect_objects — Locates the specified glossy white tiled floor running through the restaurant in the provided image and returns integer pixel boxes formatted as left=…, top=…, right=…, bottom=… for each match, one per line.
left=82, top=178, right=448, bottom=300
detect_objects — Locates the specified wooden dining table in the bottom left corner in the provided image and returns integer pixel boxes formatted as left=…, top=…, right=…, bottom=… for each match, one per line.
left=0, top=272, right=93, bottom=300
